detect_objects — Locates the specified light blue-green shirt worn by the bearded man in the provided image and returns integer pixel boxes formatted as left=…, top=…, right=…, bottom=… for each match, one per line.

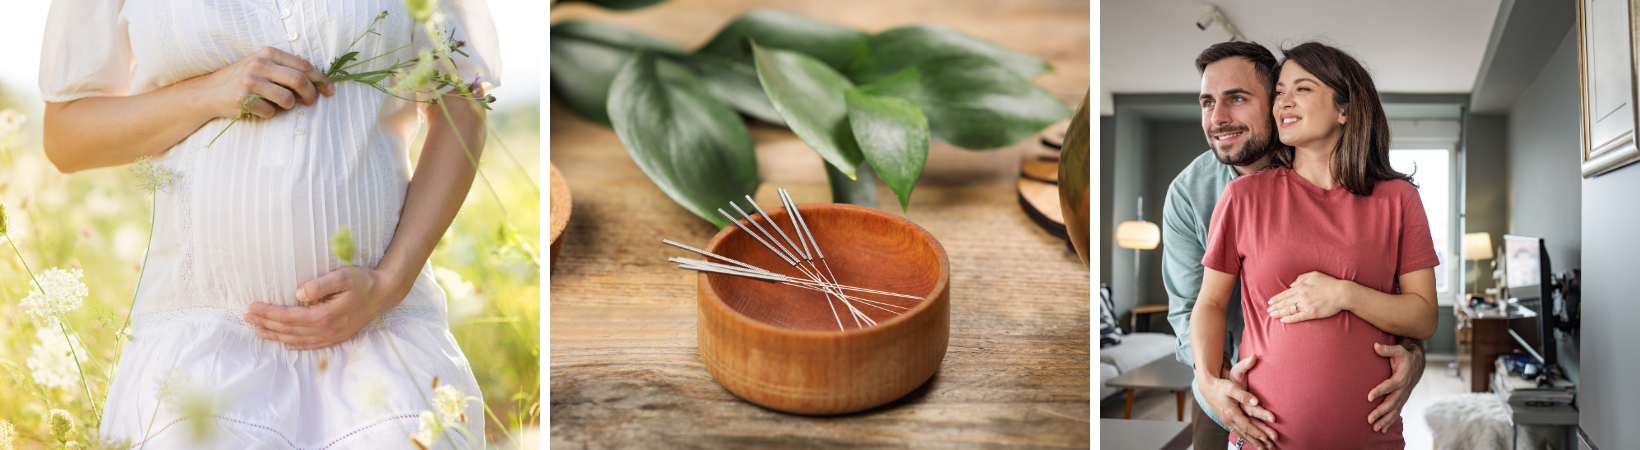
left=1161, top=149, right=1241, bottom=425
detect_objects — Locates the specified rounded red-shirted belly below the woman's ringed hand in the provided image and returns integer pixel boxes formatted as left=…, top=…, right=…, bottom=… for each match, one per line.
left=1240, top=312, right=1404, bottom=448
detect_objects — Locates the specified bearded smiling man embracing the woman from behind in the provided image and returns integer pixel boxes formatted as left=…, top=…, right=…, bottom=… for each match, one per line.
left=1161, top=43, right=1424, bottom=448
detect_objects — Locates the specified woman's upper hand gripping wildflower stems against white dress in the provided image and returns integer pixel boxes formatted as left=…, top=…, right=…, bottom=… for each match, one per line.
left=198, top=48, right=336, bottom=118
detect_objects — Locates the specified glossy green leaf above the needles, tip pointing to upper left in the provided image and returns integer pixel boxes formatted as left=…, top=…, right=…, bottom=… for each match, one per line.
left=751, top=43, right=864, bottom=177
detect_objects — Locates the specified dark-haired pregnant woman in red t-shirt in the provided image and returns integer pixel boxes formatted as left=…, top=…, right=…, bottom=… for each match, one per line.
left=1191, top=43, right=1440, bottom=448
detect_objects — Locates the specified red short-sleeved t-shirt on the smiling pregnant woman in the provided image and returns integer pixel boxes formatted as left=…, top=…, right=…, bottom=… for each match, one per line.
left=1202, top=168, right=1440, bottom=448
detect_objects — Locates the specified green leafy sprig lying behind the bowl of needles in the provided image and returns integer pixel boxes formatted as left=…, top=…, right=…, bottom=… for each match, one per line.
left=551, top=10, right=1071, bottom=227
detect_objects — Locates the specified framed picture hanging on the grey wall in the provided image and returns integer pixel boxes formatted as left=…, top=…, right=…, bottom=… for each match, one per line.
left=1578, top=0, right=1640, bottom=177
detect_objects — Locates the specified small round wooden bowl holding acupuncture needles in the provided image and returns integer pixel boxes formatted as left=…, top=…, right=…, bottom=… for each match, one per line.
left=695, top=204, right=951, bottom=416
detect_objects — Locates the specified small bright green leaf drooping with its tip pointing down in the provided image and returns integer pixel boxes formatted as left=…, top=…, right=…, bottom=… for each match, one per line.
left=843, top=89, right=928, bottom=212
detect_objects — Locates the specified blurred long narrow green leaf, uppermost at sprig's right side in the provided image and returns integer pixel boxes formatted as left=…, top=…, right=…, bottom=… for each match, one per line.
left=843, top=25, right=1053, bottom=84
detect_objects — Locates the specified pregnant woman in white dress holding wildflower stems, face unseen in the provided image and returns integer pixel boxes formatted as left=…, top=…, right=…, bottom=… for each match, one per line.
left=39, top=0, right=500, bottom=448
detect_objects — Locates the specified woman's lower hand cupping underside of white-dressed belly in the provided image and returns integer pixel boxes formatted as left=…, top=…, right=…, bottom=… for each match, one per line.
left=244, top=268, right=415, bottom=350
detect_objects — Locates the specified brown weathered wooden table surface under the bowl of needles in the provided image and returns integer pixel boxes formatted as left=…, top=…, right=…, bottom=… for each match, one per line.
left=549, top=0, right=1092, bottom=448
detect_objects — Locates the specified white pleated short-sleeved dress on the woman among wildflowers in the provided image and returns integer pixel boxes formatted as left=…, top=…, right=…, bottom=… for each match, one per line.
left=39, top=0, right=500, bottom=450
